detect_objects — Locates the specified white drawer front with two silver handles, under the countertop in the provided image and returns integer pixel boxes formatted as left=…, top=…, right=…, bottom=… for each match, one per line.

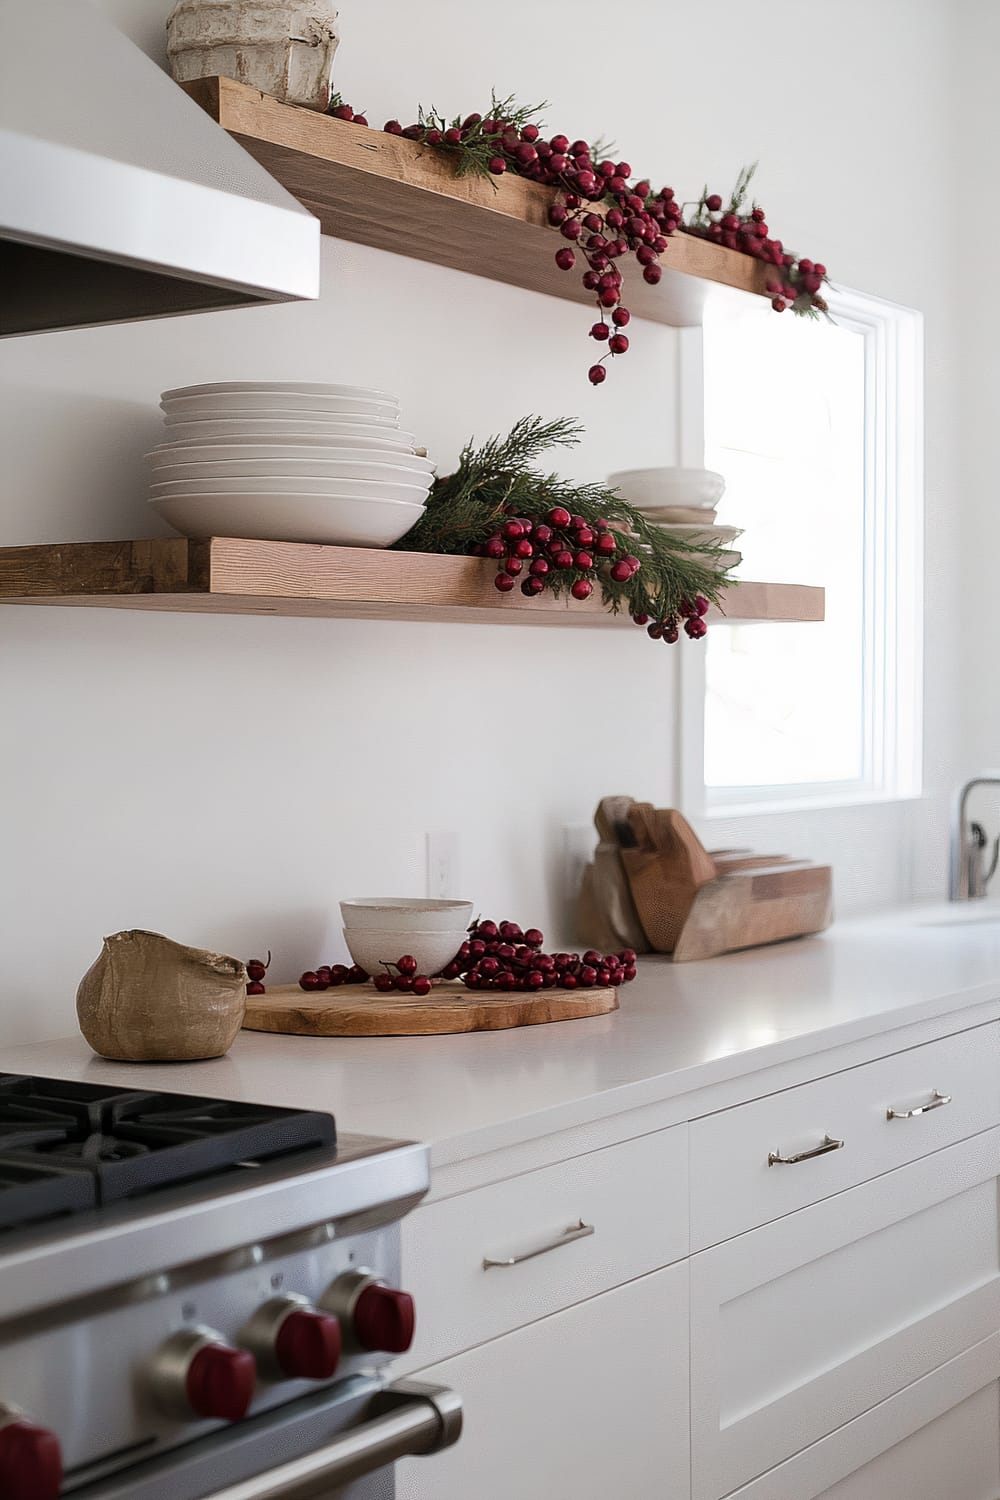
left=691, top=1022, right=1000, bottom=1250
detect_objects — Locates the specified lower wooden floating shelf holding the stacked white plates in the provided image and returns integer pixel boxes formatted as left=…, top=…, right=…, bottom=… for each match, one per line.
left=0, top=537, right=825, bottom=630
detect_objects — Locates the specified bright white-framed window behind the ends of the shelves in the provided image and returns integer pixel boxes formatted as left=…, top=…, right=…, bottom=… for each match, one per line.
left=692, top=293, right=922, bottom=815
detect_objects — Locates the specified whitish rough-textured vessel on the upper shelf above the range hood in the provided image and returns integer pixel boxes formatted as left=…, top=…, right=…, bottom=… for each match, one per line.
left=166, top=0, right=340, bottom=110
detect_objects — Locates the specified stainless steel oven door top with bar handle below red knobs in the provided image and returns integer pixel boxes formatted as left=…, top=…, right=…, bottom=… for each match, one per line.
left=63, top=1382, right=462, bottom=1500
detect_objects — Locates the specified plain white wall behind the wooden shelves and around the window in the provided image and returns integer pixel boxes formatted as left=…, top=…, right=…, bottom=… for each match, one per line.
left=0, top=0, right=958, bottom=1040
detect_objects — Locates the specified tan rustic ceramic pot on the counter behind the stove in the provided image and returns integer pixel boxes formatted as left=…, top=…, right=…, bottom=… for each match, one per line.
left=76, top=932, right=246, bottom=1062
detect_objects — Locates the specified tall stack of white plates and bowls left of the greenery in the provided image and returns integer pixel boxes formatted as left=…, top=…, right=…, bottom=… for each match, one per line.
left=147, top=381, right=433, bottom=548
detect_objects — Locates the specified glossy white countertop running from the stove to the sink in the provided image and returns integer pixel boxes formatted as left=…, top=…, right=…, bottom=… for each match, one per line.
left=0, top=903, right=1000, bottom=1166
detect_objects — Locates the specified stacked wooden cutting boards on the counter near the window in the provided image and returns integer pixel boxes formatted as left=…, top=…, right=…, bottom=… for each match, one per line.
left=580, top=797, right=834, bottom=963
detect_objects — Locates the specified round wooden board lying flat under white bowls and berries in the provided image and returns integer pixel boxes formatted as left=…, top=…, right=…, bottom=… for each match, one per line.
left=243, top=981, right=618, bottom=1037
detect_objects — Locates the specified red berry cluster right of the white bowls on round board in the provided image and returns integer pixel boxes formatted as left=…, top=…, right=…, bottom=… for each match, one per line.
left=441, top=921, right=636, bottom=990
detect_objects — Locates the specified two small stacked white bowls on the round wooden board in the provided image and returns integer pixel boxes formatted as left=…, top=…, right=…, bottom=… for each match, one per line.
left=340, top=896, right=472, bottom=977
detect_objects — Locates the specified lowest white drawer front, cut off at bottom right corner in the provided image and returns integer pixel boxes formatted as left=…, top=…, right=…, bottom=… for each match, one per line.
left=729, top=1334, right=1000, bottom=1500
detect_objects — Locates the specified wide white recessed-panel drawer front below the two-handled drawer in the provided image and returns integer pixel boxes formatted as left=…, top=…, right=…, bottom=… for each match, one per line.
left=691, top=1128, right=1000, bottom=1500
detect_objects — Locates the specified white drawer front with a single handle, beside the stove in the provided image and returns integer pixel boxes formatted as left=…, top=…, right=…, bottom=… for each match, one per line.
left=400, top=1125, right=688, bottom=1370
